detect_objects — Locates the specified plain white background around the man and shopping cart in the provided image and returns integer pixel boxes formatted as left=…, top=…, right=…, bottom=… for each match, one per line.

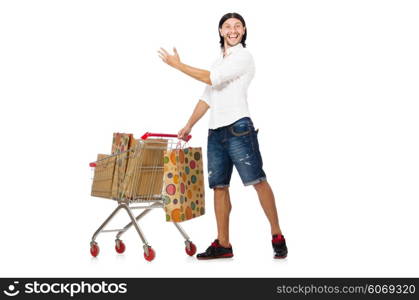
left=0, top=0, right=419, bottom=277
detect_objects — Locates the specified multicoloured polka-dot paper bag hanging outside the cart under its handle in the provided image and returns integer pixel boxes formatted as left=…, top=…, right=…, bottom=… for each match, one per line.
left=162, top=147, right=205, bottom=222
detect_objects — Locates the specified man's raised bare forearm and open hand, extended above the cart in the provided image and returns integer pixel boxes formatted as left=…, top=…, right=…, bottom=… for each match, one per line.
left=158, top=48, right=212, bottom=85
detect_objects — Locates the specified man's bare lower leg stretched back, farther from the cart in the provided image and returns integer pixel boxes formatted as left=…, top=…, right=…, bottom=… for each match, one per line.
left=253, top=181, right=282, bottom=235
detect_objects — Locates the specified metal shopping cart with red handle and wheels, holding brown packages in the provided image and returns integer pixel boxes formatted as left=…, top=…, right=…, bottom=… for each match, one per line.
left=90, top=132, right=196, bottom=261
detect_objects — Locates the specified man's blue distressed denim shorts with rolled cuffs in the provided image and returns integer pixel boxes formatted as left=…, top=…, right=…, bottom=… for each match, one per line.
left=207, top=117, right=266, bottom=188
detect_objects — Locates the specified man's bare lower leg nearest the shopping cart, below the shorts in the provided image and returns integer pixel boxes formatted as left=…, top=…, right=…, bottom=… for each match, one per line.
left=214, top=187, right=231, bottom=247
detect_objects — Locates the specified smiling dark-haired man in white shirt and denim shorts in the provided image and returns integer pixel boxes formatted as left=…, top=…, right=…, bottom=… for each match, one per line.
left=158, top=13, right=288, bottom=259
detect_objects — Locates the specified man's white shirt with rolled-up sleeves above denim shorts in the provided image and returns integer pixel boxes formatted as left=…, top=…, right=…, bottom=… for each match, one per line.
left=201, top=44, right=255, bottom=129
